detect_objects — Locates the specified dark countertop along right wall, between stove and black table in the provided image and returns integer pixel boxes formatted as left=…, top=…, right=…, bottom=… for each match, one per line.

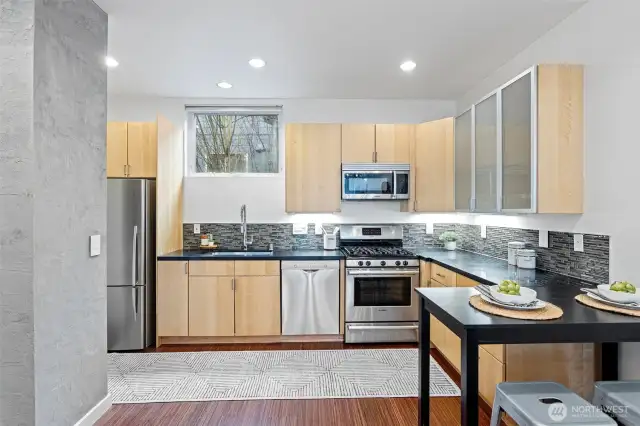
left=409, top=248, right=595, bottom=287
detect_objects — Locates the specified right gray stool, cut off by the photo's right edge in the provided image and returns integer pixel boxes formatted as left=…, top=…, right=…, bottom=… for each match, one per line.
left=593, top=381, right=640, bottom=426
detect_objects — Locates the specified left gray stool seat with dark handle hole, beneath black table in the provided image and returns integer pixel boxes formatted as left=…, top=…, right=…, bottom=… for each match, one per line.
left=491, top=382, right=616, bottom=426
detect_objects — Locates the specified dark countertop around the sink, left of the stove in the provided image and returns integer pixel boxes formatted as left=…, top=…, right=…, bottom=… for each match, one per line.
left=158, top=250, right=344, bottom=260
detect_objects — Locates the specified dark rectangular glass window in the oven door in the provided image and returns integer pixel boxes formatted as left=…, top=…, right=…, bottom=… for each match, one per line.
left=353, top=277, right=411, bottom=306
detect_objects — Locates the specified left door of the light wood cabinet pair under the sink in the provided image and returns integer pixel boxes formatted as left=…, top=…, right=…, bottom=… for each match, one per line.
left=189, top=276, right=235, bottom=336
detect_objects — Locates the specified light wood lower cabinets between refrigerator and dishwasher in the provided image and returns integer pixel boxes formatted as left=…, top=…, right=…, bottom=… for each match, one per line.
left=156, top=260, right=281, bottom=337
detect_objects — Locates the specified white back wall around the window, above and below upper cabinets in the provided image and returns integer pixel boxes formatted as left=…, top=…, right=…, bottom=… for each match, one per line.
left=108, top=96, right=455, bottom=223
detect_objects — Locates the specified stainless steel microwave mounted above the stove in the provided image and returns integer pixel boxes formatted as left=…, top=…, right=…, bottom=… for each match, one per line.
left=342, top=163, right=411, bottom=200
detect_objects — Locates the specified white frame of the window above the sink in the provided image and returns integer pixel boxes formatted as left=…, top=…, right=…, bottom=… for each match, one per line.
left=184, top=105, right=284, bottom=178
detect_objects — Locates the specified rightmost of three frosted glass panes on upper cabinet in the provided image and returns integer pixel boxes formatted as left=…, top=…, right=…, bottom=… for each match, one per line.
left=502, top=73, right=534, bottom=210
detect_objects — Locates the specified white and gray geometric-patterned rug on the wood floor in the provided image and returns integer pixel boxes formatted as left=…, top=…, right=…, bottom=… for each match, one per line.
left=109, top=349, right=460, bottom=404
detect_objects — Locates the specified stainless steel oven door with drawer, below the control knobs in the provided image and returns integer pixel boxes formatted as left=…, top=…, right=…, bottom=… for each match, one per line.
left=345, top=267, right=420, bottom=343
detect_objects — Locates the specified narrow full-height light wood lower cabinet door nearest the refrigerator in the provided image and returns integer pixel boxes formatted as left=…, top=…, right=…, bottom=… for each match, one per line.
left=156, top=261, right=189, bottom=336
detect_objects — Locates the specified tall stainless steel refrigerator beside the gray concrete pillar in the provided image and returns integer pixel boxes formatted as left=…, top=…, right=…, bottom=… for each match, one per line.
left=107, top=179, right=156, bottom=351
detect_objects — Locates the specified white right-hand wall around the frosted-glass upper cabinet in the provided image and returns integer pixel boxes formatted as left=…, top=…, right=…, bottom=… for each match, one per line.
left=457, top=0, right=640, bottom=378
